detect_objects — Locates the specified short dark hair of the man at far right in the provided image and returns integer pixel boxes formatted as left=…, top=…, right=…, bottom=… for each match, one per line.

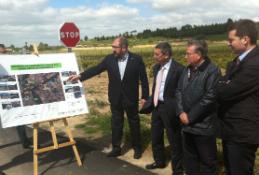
left=228, top=19, right=258, bottom=44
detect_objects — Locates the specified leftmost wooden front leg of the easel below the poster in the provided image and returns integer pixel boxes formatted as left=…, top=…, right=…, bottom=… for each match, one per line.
left=33, top=123, right=39, bottom=175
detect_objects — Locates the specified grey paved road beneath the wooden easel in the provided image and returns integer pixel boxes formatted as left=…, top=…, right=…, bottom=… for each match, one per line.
left=0, top=128, right=154, bottom=175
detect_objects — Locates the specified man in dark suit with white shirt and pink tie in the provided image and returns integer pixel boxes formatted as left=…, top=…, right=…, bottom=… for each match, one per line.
left=146, top=42, right=184, bottom=175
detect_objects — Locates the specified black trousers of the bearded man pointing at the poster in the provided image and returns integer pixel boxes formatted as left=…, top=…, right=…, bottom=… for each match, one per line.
left=111, top=102, right=141, bottom=150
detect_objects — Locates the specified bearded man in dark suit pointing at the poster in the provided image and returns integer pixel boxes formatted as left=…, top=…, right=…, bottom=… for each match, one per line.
left=69, top=37, right=149, bottom=159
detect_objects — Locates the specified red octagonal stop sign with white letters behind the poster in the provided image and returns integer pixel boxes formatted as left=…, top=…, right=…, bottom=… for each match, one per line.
left=59, top=22, right=80, bottom=48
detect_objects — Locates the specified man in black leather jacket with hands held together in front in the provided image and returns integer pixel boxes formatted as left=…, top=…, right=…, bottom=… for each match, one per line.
left=176, top=39, right=220, bottom=175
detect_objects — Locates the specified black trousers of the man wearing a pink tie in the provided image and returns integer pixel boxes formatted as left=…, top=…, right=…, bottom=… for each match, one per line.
left=151, top=104, right=183, bottom=175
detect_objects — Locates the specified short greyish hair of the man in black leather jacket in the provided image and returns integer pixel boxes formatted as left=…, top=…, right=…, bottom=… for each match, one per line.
left=187, top=38, right=208, bottom=58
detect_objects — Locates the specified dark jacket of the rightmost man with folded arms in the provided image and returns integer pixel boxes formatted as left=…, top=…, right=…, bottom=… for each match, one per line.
left=217, top=46, right=259, bottom=144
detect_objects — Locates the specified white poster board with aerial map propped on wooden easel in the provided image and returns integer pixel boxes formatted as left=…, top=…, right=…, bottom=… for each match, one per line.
left=0, top=53, right=88, bottom=128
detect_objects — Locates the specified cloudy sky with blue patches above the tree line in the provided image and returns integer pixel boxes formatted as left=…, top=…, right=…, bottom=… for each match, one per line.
left=0, top=0, right=259, bottom=47
